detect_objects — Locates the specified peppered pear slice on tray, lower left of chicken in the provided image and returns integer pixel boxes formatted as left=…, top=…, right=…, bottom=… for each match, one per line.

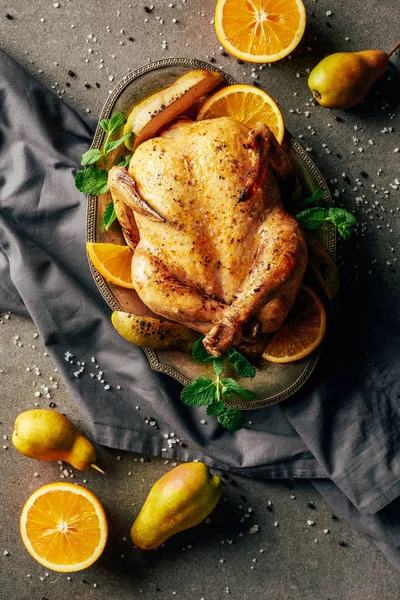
left=111, top=310, right=199, bottom=352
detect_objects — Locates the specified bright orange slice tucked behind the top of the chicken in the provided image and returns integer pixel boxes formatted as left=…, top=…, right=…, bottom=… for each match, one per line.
left=197, top=84, right=285, bottom=144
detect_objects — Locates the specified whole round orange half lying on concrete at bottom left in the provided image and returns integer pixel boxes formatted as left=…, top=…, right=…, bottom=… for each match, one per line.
left=20, top=483, right=108, bottom=573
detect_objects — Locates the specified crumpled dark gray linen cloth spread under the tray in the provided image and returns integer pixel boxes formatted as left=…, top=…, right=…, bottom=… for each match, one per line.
left=0, top=52, right=400, bottom=568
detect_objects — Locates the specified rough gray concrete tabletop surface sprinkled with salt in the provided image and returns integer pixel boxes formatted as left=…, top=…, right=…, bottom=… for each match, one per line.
left=0, top=0, right=400, bottom=600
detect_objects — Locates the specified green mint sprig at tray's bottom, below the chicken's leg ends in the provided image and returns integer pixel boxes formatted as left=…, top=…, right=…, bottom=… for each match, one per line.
left=181, top=337, right=256, bottom=432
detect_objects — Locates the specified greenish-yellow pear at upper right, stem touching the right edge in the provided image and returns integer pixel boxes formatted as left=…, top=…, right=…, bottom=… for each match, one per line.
left=308, top=44, right=399, bottom=109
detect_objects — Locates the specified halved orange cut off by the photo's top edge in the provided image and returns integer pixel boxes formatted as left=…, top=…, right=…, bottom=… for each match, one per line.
left=215, top=0, right=306, bottom=63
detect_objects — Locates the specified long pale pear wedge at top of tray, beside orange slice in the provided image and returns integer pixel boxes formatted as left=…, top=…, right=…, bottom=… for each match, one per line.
left=124, top=69, right=223, bottom=150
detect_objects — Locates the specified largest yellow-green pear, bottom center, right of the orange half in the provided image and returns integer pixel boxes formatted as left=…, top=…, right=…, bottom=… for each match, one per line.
left=131, top=462, right=222, bottom=550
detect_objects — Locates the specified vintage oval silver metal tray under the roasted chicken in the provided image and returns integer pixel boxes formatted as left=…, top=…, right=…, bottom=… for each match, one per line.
left=87, top=58, right=336, bottom=410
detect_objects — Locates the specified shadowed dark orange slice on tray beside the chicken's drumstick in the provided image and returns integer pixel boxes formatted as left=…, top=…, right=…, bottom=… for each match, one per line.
left=262, top=285, right=326, bottom=363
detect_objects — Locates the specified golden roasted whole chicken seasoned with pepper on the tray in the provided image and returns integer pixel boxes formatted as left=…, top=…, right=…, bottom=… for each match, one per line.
left=109, top=117, right=307, bottom=356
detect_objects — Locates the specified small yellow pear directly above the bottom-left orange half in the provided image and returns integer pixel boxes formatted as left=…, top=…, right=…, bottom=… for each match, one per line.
left=12, top=408, right=102, bottom=472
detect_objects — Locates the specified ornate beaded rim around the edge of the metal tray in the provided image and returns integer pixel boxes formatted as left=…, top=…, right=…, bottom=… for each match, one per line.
left=86, top=58, right=338, bottom=410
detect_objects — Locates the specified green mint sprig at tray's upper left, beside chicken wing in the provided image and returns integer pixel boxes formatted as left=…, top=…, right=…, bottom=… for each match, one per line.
left=75, top=113, right=132, bottom=204
